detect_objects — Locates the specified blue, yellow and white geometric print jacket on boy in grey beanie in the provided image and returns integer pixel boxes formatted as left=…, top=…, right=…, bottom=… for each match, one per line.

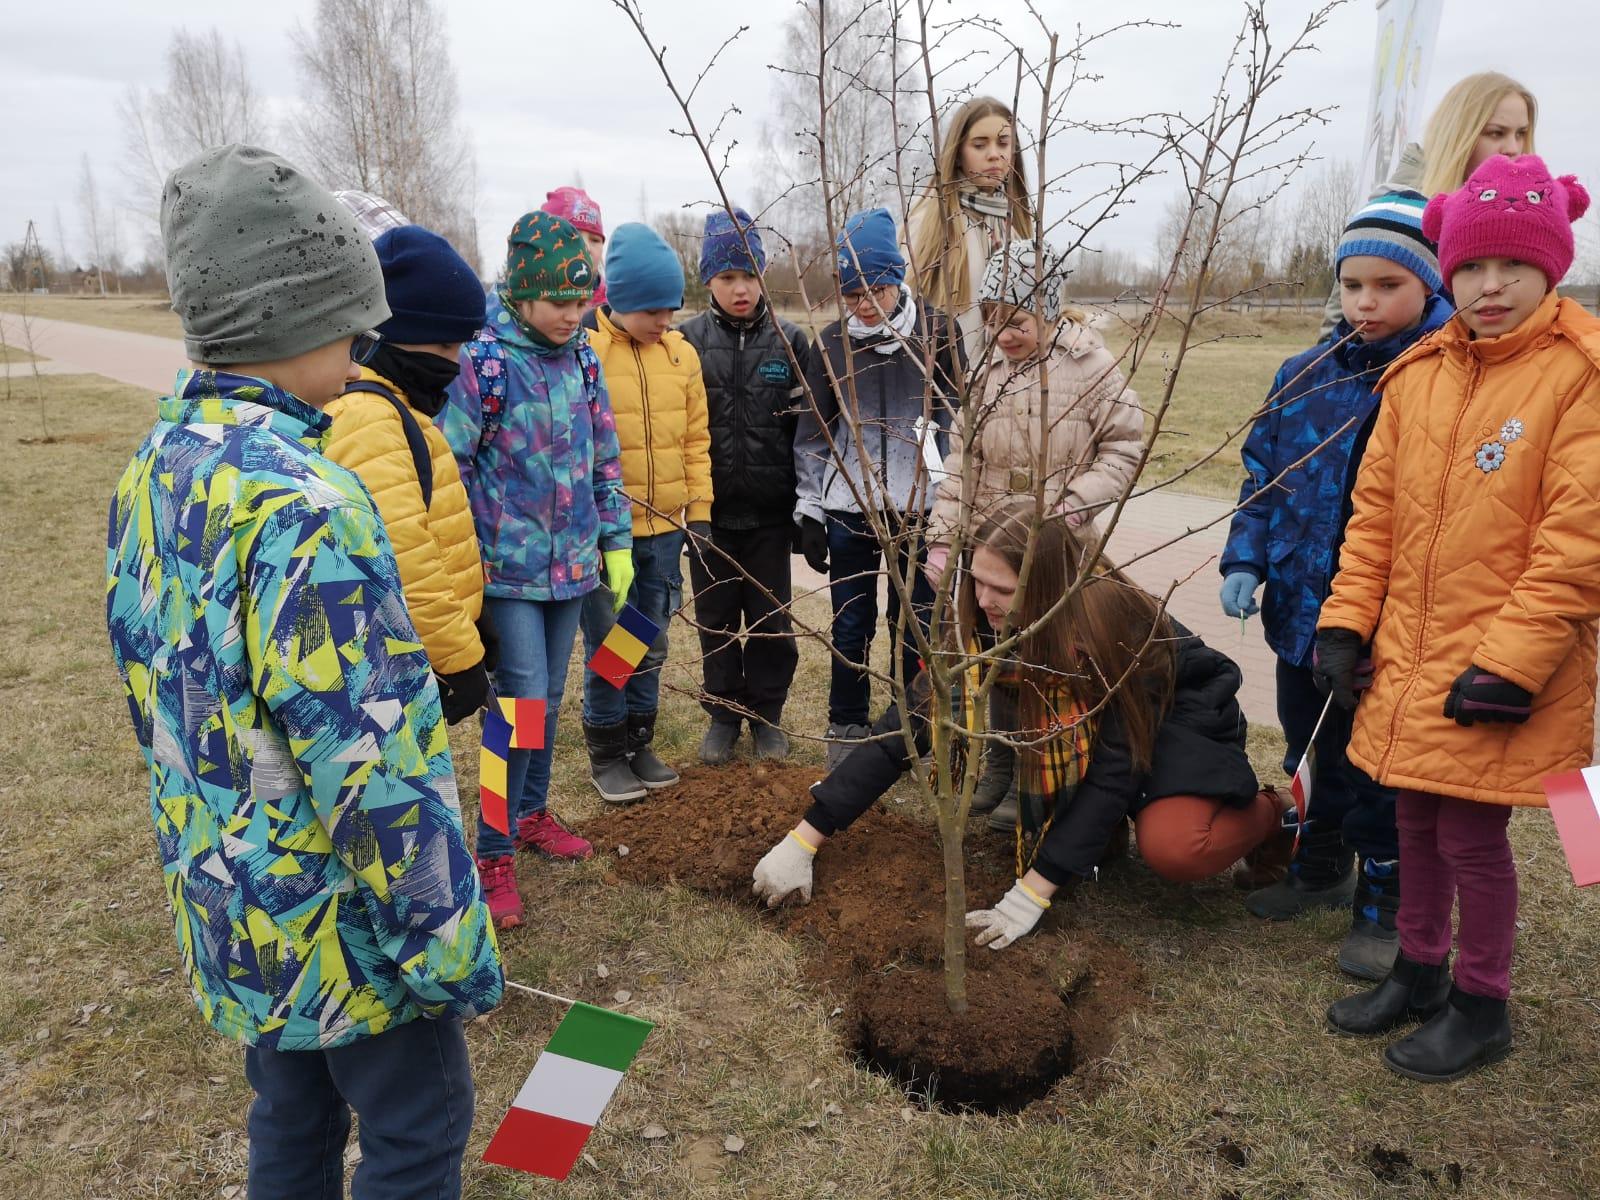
left=106, top=371, right=502, bottom=1050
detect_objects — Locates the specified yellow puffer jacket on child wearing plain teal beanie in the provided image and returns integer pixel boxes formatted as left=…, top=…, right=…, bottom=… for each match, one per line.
left=587, top=309, right=712, bottom=538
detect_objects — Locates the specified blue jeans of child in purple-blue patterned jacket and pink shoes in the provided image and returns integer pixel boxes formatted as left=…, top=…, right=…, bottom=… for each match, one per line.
left=478, top=595, right=584, bottom=858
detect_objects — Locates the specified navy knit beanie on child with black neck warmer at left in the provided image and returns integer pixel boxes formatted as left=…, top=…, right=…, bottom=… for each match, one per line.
left=373, top=226, right=486, bottom=346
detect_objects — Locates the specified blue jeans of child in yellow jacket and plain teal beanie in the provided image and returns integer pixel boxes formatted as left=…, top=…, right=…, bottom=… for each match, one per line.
left=581, top=530, right=683, bottom=726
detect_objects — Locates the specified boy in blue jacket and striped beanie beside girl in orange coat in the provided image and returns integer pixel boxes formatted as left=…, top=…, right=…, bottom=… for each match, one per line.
left=1221, top=192, right=1451, bottom=979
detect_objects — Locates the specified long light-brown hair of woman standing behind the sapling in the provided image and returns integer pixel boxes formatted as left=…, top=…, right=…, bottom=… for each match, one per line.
left=907, top=96, right=1034, bottom=315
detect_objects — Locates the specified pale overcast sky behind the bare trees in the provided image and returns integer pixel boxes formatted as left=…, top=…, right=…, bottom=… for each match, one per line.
left=0, top=0, right=1600, bottom=273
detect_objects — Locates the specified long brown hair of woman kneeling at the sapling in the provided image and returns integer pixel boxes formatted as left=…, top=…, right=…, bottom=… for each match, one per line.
left=966, top=501, right=1178, bottom=771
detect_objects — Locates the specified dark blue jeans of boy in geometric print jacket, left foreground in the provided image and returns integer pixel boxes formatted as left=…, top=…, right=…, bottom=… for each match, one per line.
left=245, top=1019, right=472, bottom=1200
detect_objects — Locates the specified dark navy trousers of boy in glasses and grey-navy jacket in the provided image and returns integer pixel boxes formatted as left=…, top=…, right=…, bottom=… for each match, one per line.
left=827, top=512, right=933, bottom=725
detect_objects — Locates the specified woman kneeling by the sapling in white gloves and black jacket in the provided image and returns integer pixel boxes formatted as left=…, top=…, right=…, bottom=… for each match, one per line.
left=754, top=504, right=1286, bottom=950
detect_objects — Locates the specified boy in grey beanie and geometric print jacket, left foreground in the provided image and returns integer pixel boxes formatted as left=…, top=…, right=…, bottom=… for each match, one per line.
left=106, top=146, right=502, bottom=1197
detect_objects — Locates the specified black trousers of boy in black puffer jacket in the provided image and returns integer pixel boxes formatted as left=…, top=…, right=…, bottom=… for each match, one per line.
left=690, top=525, right=800, bottom=725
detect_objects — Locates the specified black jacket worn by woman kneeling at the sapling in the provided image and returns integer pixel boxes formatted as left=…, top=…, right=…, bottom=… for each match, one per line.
left=805, top=622, right=1258, bottom=885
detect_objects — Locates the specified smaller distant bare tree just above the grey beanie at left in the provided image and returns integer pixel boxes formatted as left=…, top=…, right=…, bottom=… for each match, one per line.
left=117, top=29, right=266, bottom=222
